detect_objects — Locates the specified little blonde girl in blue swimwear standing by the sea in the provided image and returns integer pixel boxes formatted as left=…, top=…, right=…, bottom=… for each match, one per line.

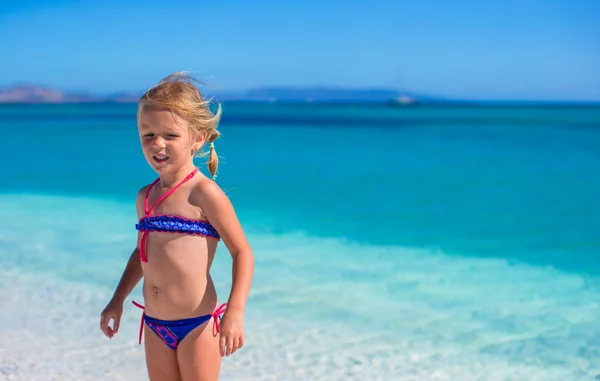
left=100, top=73, right=254, bottom=381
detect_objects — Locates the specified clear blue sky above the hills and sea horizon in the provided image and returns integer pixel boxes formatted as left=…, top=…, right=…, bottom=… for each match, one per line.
left=0, top=0, right=600, bottom=100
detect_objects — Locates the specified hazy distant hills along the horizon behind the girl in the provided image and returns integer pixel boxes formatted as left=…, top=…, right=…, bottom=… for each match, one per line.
left=0, top=84, right=428, bottom=104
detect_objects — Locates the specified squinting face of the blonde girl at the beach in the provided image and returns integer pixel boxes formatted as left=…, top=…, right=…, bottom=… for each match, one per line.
left=138, top=105, right=204, bottom=174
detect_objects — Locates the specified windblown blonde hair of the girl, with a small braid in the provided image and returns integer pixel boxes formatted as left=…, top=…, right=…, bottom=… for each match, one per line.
left=138, top=72, right=221, bottom=180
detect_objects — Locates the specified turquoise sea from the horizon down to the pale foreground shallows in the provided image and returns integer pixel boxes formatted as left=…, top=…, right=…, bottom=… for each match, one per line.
left=0, top=103, right=600, bottom=381
